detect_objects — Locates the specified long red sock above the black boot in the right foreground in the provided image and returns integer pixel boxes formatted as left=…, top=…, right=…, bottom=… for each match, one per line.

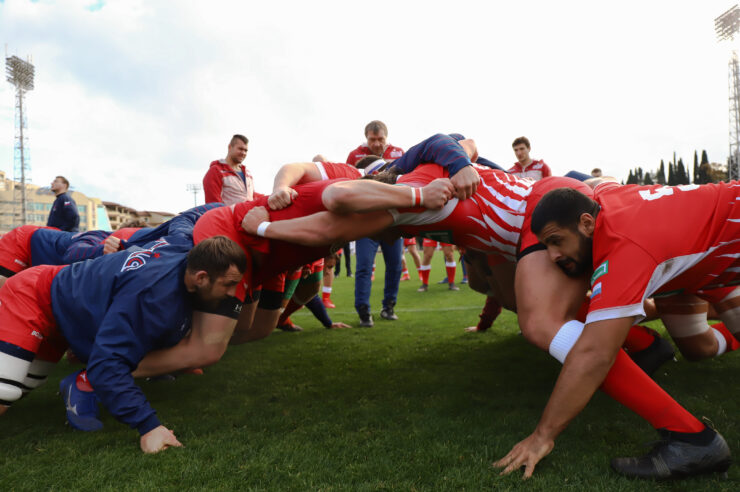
left=601, top=350, right=704, bottom=432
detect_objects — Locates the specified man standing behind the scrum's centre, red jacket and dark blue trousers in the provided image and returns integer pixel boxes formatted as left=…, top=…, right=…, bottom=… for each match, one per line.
left=347, top=120, right=403, bottom=327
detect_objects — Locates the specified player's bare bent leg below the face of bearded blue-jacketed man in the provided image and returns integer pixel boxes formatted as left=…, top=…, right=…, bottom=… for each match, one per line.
left=133, top=312, right=238, bottom=378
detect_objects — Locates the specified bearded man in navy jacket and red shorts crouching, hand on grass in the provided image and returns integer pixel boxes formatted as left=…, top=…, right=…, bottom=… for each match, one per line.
left=0, top=235, right=247, bottom=452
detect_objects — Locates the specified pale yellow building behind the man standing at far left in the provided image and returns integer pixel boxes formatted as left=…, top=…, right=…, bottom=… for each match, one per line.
left=0, top=171, right=110, bottom=234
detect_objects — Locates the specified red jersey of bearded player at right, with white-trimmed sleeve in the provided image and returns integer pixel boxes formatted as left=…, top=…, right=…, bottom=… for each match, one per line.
left=586, top=182, right=740, bottom=322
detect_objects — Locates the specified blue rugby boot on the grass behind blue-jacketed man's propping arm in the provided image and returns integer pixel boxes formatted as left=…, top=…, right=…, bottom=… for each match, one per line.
left=59, top=369, right=103, bottom=432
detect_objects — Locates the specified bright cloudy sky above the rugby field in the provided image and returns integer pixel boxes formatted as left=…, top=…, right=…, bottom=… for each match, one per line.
left=0, top=0, right=740, bottom=212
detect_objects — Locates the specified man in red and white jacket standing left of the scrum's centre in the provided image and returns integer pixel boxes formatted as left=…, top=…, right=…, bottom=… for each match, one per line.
left=203, top=134, right=254, bottom=205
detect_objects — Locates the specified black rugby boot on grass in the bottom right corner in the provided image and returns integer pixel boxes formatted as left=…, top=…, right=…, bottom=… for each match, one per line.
left=611, top=427, right=732, bottom=480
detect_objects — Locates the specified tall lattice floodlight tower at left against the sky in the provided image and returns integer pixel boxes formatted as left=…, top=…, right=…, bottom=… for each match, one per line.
left=5, top=56, right=34, bottom=225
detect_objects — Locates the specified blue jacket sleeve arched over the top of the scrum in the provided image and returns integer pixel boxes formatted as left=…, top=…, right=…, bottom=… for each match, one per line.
left=391, top=133, right=503, bottom=176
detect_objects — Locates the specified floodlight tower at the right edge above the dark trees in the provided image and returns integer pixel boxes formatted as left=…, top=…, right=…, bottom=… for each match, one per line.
left=714, top=4, right=740, bottom=180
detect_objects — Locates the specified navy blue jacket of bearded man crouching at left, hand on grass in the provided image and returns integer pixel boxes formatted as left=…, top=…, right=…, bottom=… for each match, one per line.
left=51, top=236, right=195, bottom=435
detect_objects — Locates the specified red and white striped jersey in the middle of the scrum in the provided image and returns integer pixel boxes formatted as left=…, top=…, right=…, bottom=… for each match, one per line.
left=390, top=164, right=534, bottom=262
